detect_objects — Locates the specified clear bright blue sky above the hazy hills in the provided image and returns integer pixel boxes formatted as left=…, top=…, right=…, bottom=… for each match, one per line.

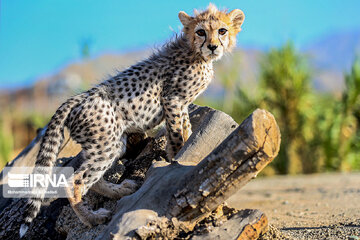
left=0, top=0, right=360, bottom=88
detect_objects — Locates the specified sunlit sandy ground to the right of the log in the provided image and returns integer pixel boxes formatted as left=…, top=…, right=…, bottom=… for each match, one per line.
left=227, top=173, right=360, bottom=239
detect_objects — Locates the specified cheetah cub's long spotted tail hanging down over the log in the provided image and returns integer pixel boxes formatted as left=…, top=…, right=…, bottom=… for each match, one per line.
left=20, top=93, right=86, bottom=238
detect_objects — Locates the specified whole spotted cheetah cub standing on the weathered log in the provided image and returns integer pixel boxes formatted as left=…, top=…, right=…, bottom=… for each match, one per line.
left=20, top=4, right=245, bottom=235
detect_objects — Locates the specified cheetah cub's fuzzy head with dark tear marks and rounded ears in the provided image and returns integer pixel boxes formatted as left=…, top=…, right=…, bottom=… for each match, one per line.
left=179, top=3, right=245, bottom=61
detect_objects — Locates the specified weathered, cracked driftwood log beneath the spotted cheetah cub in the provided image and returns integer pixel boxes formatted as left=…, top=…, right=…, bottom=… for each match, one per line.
left=0, top=105, right=280, bottom=239
